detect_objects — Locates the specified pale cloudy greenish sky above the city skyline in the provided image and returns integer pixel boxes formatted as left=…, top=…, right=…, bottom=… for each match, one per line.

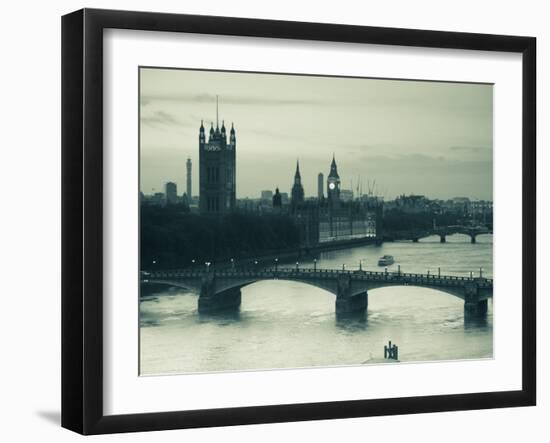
left=140, top=68, right=493, bottom=200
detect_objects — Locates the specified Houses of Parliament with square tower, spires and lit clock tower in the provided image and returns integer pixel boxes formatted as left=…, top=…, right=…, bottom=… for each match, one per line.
left=197, top=98, right=376, bottom=245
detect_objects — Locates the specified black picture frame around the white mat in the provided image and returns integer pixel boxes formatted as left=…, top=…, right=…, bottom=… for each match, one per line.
left=62, top=9, right=536, bottom=434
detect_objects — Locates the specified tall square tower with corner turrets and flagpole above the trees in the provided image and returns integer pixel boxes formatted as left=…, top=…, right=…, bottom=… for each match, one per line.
left=199, top=96, right=237, bottom=215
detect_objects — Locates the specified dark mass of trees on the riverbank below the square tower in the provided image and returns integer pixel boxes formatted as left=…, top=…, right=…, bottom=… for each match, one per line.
left=140, top=206, right=300, bottom=269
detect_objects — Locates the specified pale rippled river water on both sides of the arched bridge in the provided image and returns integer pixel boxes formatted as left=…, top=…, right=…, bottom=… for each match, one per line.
left=140, top=234, right=493, bottom=375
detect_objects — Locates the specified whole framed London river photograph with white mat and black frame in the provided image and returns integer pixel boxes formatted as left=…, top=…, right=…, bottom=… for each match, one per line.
left=62, top=9, right=536, bottom=434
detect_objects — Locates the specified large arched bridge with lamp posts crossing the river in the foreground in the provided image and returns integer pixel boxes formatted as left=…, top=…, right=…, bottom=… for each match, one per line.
left=142, top=267, right=493, bottom=318
